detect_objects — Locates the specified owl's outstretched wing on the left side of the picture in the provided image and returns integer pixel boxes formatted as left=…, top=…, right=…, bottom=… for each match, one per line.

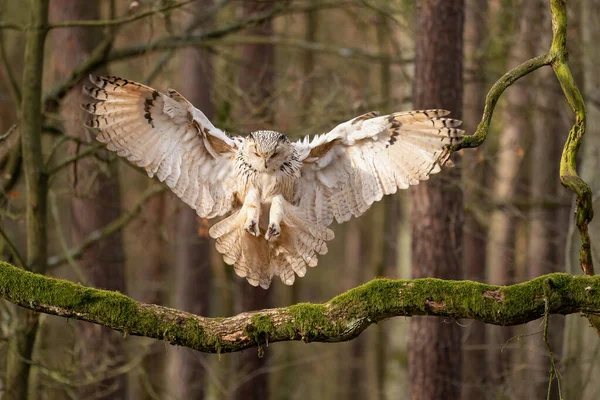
left=83, top=76, right=242, bottom=218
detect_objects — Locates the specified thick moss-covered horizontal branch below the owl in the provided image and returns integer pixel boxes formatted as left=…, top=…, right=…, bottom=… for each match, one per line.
left=0, top=262, right=600, bottom=353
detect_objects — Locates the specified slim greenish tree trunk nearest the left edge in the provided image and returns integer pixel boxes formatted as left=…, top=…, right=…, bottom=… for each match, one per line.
left=4, top=0, right=48, bottom=400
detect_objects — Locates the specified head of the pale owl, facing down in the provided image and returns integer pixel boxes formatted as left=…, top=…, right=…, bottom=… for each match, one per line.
left=244, top=131, right=294, bottom=172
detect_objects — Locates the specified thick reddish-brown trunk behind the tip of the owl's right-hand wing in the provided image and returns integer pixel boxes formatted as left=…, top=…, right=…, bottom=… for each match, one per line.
left=408, top=0, right=464, bottom=400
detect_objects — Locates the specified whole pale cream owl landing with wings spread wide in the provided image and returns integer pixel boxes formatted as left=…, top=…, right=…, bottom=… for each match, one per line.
left=83, top=76, right=464, bottom=289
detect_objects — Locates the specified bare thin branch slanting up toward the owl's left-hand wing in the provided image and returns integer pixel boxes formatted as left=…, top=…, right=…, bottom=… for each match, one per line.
left=48, top=185, right=166, bottom=267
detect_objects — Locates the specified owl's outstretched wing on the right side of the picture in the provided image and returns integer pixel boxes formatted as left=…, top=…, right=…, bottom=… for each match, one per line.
left=295, top=110, right=464, bottom=226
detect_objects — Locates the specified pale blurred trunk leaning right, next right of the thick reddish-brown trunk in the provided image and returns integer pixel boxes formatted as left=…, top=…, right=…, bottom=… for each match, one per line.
left=486, top=1, right=539, bottom=392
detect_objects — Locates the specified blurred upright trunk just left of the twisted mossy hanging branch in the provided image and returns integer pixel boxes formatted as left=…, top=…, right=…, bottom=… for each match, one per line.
left=526, top=0, right=577, bottom=399
